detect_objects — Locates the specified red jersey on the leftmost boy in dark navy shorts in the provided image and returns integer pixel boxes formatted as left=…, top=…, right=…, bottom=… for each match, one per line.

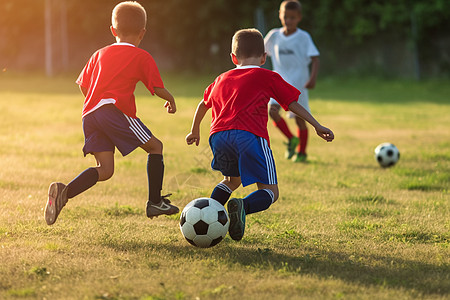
left=76, top=43, right=164, bottom=118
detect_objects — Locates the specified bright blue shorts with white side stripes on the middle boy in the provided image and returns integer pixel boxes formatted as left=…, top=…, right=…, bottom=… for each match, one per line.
left=209, top=130, right=277, bottom=186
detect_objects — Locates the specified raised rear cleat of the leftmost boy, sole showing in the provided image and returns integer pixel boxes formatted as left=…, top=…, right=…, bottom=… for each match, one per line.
left=44, top=182, right=69, bottom=225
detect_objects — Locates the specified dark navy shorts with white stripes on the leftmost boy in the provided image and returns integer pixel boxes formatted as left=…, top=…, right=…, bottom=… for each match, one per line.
left=83, top=104, right=152, bottom=156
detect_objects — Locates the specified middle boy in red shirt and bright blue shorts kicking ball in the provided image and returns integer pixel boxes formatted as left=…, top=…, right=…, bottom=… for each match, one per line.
left=186, top=29, right=334, bottom=240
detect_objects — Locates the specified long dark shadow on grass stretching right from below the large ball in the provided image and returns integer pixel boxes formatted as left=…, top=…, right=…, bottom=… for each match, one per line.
left=110, top=237, right=450, bottom=295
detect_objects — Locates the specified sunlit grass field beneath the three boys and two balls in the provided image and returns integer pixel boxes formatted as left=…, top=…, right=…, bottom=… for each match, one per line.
left=0, top=73, right=450, bottom=299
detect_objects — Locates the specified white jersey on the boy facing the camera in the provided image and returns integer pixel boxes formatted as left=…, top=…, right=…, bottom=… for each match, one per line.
left=264, top=28, right=319, bottom=90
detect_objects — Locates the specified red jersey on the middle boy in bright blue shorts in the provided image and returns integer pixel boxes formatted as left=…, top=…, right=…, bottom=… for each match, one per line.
left=203, top=66, right=300, bottom=142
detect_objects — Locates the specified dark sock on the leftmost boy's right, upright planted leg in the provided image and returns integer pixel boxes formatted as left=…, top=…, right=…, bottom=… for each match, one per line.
left=147, top=154, right=164, bottom=204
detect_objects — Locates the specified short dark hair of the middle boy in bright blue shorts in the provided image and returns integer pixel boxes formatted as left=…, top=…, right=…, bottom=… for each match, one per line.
left=231, top=28, right=264, bottom=58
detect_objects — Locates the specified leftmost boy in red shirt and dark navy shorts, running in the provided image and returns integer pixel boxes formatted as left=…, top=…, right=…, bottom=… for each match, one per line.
left=44, top=1, right=179, bottom=225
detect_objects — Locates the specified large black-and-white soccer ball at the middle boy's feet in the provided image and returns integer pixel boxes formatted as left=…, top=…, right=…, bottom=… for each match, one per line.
left=180, top=198, right=230, bottom=248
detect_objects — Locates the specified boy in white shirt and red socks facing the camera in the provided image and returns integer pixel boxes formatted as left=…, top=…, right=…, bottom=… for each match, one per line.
left=264, top=0, right=319, bottom=162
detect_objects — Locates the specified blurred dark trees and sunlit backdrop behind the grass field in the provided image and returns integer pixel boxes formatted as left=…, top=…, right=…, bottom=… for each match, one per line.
left=0, top=0, right=450, bottom=79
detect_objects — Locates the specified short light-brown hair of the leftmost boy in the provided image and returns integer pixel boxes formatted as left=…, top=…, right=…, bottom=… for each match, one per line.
left=111, top=1, right=147, bottom=36
